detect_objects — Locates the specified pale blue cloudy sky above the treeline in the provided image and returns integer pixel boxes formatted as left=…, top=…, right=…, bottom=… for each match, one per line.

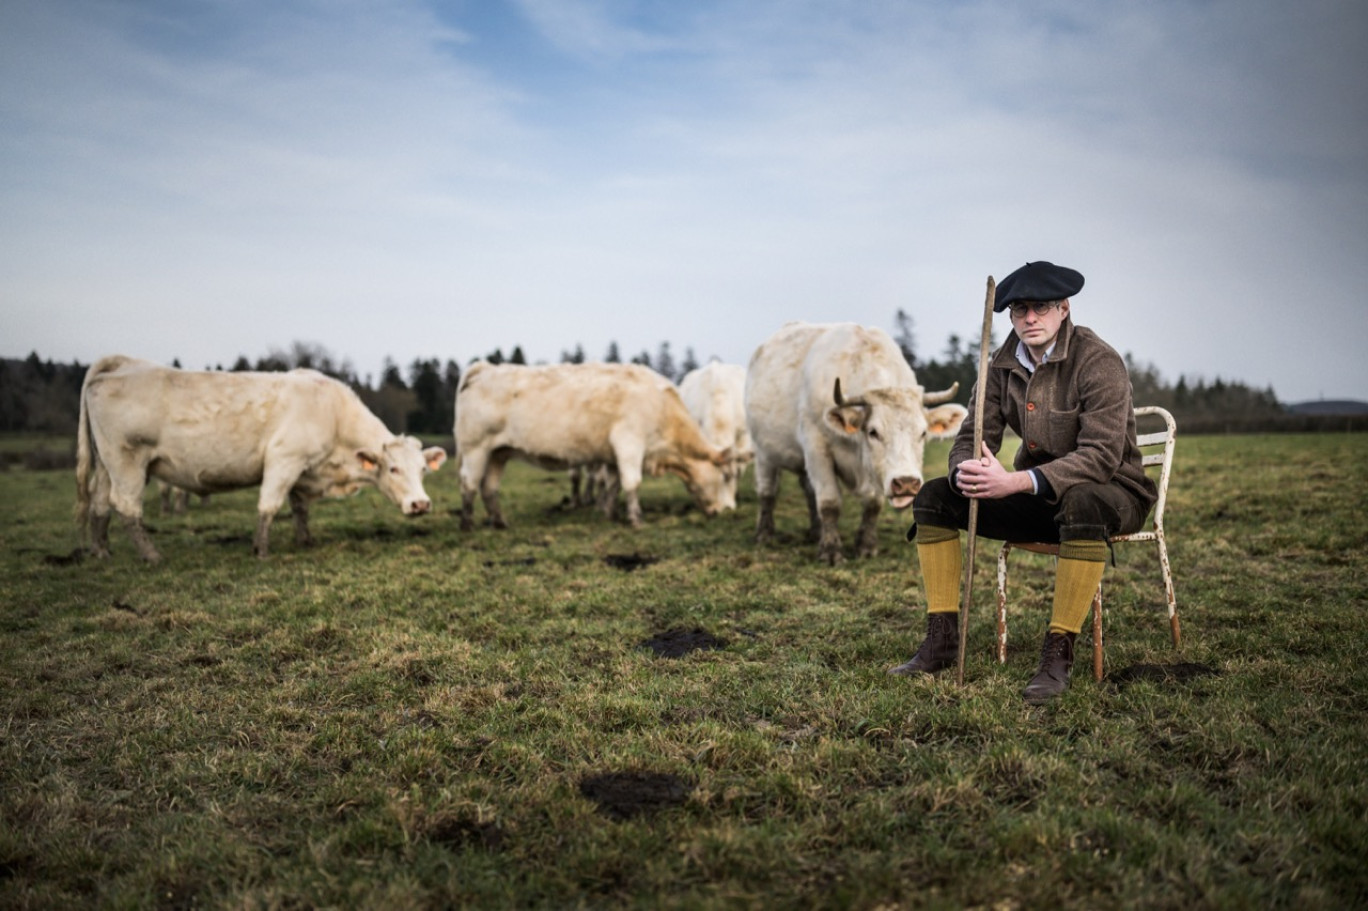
left=0, top=0, right=1368, bottom=402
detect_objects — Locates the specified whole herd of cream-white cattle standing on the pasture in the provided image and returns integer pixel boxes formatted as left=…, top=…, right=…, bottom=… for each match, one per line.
left=77, top=323, right=966, bottom=564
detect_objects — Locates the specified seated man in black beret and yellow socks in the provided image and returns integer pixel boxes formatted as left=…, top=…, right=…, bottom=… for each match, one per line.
left=889, top=261, right=1156, bottom=704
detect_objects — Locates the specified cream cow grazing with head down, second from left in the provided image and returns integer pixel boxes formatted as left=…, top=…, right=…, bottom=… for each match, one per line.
left=456, top=361, right=731, bottom=531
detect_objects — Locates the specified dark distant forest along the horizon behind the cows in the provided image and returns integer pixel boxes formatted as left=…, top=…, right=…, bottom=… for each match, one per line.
left=0, top=311, right=1368, bottom=438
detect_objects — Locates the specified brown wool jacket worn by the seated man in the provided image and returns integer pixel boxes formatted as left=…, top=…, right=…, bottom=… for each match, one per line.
left=949, top=317, right=1157, bottom=509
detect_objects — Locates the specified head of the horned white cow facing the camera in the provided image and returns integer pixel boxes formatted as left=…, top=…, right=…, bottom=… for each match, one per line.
left=826, top=379, right=963, bottom=509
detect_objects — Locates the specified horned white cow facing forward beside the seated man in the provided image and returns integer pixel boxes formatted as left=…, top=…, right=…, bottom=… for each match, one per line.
left=746, top=323, right=967, bottom=565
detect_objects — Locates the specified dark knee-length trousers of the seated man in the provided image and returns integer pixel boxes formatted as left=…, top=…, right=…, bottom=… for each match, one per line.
left=907, top=477, right=1149, bottom=543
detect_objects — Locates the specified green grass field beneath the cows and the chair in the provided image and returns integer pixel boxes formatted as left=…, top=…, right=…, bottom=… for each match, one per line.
left=0, top=435, right=1368, bottom=908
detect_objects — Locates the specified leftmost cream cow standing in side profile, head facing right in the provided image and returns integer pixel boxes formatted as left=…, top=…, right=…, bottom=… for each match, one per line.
left=77, top=356, right=446, bottom=562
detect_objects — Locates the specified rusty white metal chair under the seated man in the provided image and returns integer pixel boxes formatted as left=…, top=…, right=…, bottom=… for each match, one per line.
left=997, top=405, right=1179, bottom=680
